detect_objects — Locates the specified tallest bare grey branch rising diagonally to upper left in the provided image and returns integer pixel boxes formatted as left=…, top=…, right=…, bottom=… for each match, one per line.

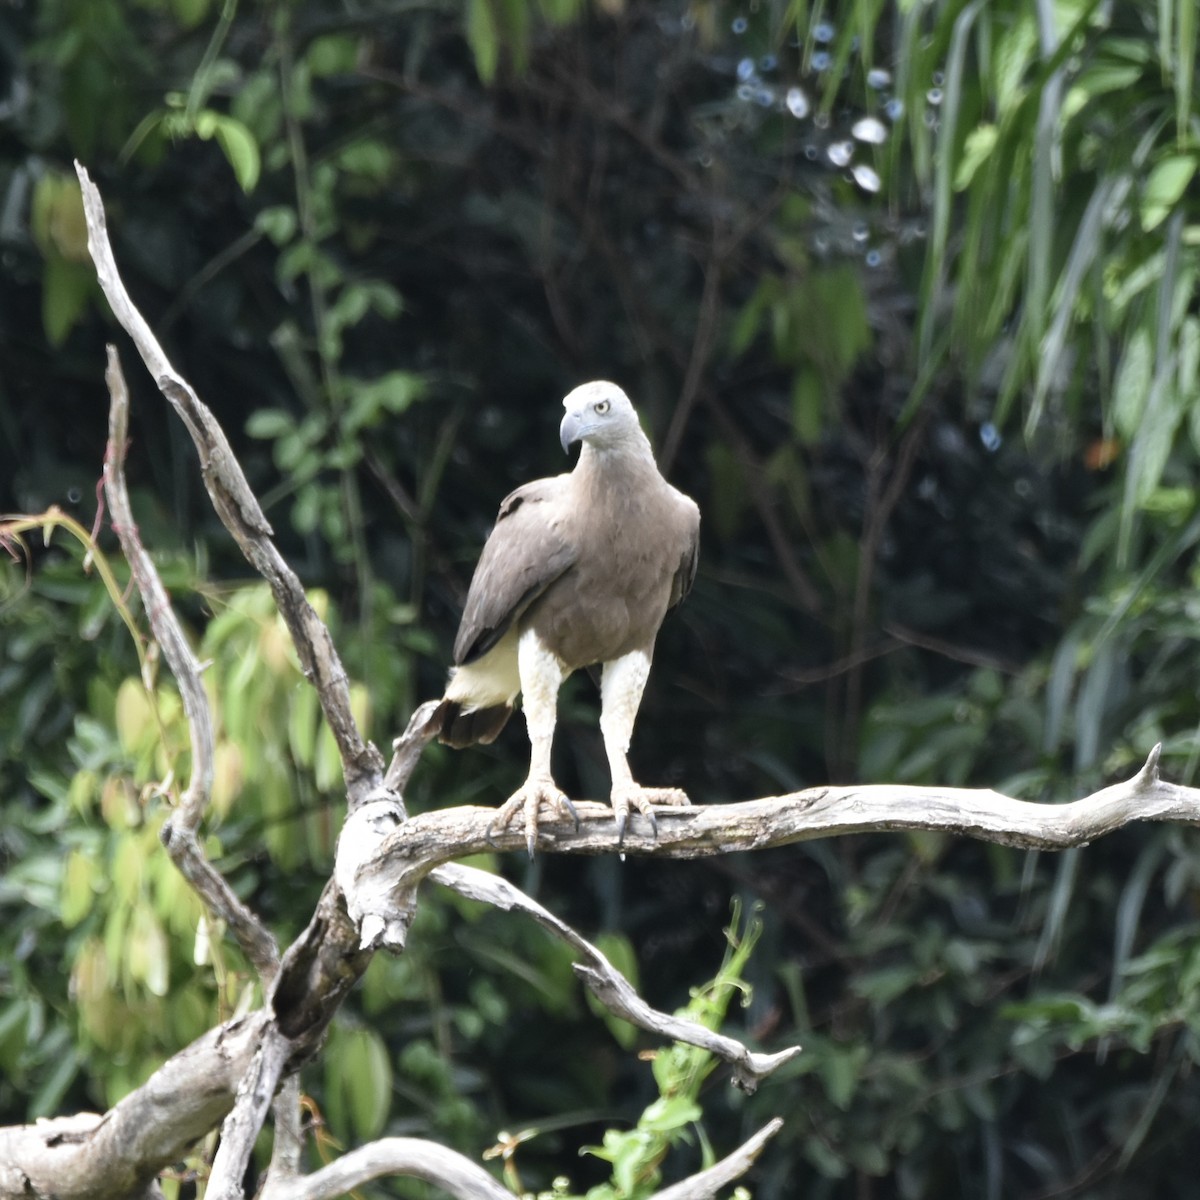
left=76, top=162, right=383, bottom=808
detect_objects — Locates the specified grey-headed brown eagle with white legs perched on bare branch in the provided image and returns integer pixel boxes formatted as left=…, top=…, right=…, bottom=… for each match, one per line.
left=431, top=380, right=700, bottom=857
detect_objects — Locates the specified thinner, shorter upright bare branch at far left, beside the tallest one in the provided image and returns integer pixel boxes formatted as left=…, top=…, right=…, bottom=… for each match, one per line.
left=104, top=346, right=280, bottom=983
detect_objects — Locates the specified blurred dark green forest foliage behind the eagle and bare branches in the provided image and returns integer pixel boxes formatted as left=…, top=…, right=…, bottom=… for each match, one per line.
left=0, top=0, right=1200, bottom=1200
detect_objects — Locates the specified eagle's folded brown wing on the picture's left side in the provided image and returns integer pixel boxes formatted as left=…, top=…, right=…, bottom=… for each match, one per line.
left=454, top=475, right=577, bottom=666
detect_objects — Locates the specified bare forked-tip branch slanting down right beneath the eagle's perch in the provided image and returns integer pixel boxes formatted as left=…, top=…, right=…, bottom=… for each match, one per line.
left=430, top=863, right=800, bottom=1092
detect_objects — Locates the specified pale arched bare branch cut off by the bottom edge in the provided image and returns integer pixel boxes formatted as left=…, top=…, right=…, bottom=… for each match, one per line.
left=262, top=1138, right=512, bottom=1200
